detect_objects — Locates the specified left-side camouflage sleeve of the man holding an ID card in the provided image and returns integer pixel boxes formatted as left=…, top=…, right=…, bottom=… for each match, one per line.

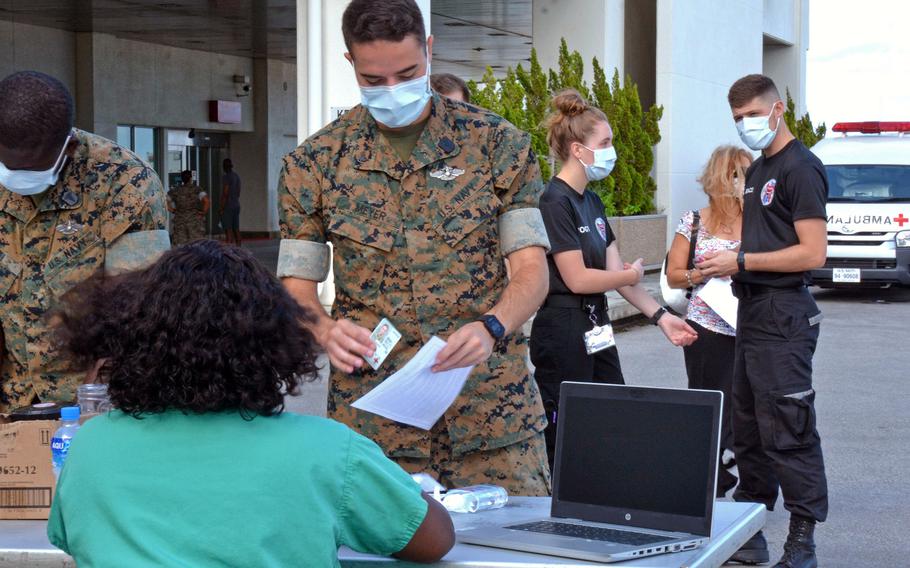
left=278, top=144, right=330, bottom=282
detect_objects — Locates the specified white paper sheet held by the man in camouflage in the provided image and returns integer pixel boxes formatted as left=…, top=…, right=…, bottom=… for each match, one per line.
left=351, top=336, right=474, bottom=430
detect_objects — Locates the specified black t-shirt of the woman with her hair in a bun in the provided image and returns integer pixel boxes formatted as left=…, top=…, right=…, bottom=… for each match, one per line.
left=540, top=177, right=615, bottom=294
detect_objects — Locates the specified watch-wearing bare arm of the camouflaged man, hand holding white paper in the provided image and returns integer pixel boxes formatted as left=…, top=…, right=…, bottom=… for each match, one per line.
left=433, top=246, right=549, bottom=372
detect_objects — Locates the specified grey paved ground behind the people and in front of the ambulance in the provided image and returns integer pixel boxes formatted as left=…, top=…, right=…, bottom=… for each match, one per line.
left=251, top=242, right=910, bottom=568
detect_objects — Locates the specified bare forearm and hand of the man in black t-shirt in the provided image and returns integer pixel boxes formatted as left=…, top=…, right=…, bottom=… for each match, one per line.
left=698, top=218, right=828, bottom=278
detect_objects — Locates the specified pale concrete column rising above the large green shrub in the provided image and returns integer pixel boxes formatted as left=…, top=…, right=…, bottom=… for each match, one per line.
left=532, top=0, right=626, bottom=84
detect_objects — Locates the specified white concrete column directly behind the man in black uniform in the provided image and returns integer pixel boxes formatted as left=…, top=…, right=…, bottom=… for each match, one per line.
left=656, top=0, right=763, bottom=242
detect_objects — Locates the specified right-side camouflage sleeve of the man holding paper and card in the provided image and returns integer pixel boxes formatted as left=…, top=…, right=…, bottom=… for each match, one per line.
left=489, top=127, right=550, bottom=256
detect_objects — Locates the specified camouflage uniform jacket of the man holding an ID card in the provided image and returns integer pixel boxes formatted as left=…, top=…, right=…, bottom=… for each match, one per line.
left=278, top=95, right=549, bottom=458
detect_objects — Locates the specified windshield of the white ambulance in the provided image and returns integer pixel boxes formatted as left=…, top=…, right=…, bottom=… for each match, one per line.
left=825, top=165, right=910, bottom=201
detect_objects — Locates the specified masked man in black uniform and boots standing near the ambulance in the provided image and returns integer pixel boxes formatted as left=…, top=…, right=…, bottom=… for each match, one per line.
left=699, top=75, right=828, bottom=568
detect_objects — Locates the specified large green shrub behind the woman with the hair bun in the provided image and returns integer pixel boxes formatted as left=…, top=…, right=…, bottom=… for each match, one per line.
left=469, top=39, right=663, bottom=215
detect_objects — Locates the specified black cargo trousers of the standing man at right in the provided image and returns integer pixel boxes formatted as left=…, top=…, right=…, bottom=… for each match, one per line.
left=733, top=284, right=828, bottom=521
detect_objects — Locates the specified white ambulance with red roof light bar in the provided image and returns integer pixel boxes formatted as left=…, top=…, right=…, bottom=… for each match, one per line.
left=812, top=122, right=910, bottom=288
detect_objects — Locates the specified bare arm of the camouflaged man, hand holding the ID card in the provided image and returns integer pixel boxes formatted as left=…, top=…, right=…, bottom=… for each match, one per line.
left=281, top=278, right=376, bottom=373
